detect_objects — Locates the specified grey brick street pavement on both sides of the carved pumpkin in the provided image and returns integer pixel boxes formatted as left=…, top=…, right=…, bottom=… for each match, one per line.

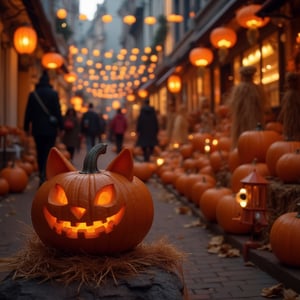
left=0, top=146, right=300, bottom=300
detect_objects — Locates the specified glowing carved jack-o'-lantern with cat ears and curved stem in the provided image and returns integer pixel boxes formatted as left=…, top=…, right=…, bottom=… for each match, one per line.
left=31, top=144, right=153, bottom=254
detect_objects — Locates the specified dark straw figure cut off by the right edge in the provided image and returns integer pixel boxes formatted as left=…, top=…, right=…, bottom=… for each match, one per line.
left=278, top=72, right=300, bottom=141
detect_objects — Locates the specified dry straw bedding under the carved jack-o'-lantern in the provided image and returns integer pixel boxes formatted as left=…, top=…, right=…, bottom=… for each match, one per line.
left=0, top=235, right=185, bottom=289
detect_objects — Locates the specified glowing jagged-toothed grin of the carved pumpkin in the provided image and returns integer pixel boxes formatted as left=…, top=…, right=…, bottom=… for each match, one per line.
left=44, top=207, right=125, bottom=239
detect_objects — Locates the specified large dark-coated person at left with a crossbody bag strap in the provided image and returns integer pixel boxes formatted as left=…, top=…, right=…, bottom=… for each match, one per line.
left=24, top=70, right=64, bottom=184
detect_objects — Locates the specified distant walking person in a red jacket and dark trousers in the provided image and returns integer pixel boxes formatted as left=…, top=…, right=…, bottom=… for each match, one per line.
left=110, top=108, right=128, bottom=153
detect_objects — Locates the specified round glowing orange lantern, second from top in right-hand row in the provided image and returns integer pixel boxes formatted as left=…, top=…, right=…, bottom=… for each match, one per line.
left=210, top=27, right=236, bottom=62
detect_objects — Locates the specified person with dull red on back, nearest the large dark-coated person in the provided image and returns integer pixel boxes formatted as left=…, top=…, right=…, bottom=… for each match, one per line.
left=62, top=108, right=80, bottom=160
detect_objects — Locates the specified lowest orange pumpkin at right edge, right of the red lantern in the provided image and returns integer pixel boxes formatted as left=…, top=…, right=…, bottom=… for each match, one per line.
left=270, top=203, right=300, bottom=267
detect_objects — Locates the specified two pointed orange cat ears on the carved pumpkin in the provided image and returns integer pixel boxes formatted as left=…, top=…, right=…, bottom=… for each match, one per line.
left=46, top=147, right=133, bottom=181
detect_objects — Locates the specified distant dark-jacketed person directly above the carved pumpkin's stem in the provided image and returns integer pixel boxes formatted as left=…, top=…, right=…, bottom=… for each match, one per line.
left=81, top=103, right=101, bottom=152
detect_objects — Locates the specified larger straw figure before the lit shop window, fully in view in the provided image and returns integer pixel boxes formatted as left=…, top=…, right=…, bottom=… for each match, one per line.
left=228, top=66, right=267, bottom=148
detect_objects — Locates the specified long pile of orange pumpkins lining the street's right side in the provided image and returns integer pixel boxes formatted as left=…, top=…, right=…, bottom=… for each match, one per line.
left=149, top=122, right=300, bottom=266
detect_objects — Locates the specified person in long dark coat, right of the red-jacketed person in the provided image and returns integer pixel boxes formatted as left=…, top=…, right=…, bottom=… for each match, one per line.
left=136, top=99, right=159, bottom=161
